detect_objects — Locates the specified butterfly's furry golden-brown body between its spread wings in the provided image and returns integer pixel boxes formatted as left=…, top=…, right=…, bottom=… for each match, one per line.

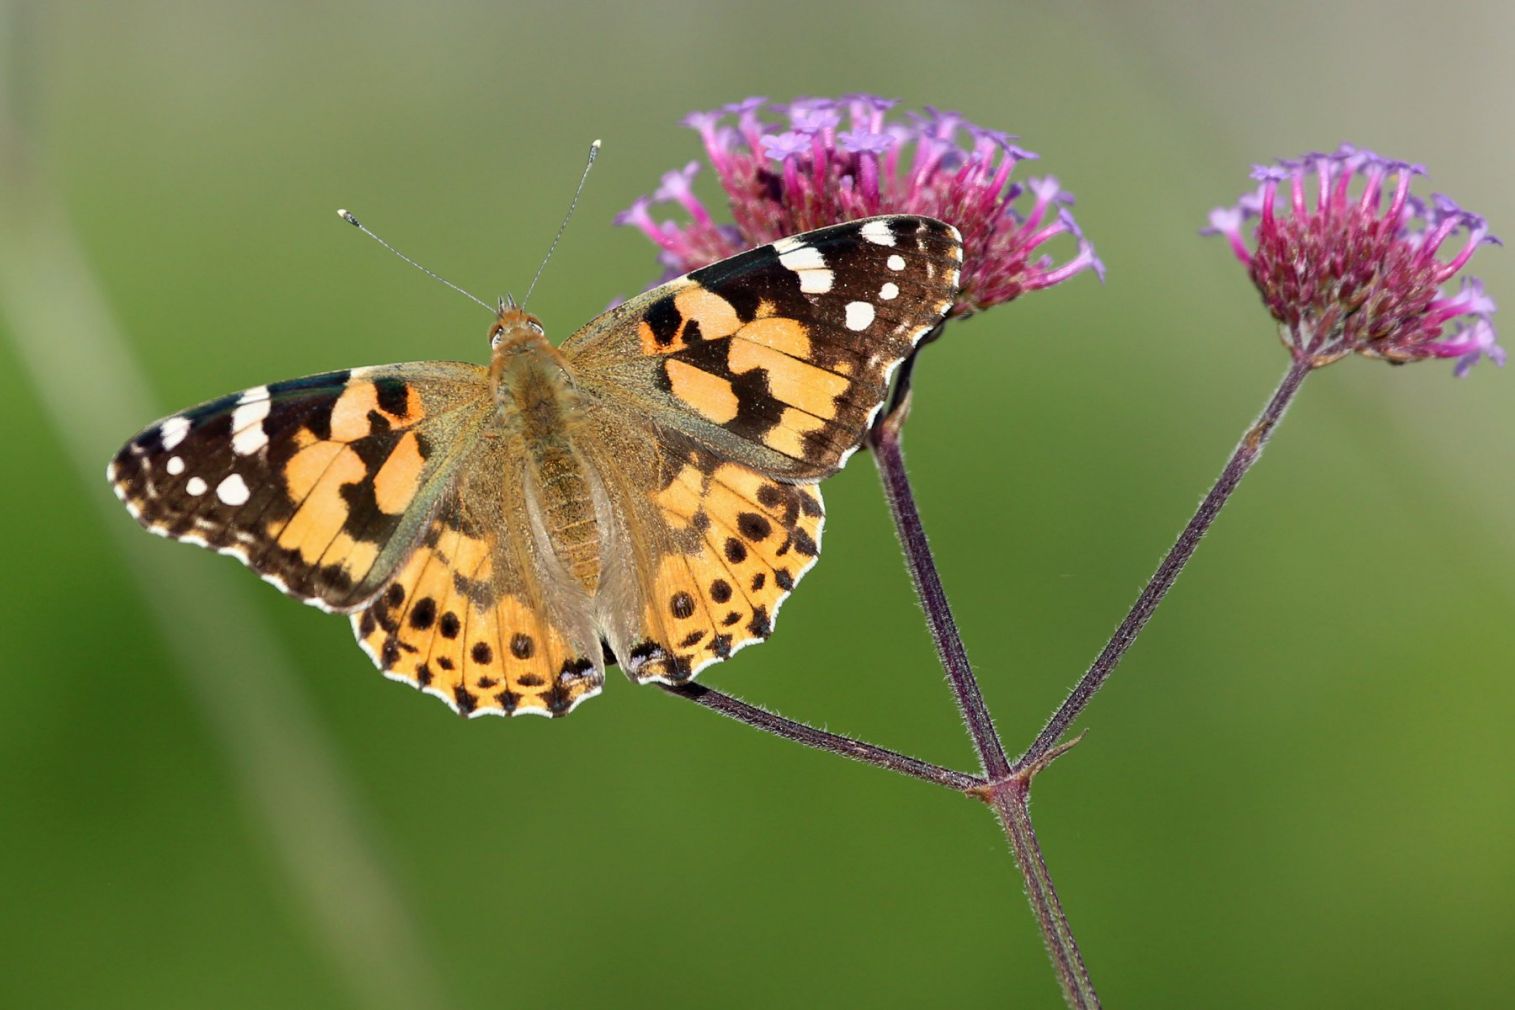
left=489, top=306, right=600, bottom=597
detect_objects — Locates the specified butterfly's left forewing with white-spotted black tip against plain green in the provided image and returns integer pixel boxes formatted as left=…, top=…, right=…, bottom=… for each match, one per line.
left=108, top=362, right=489, bottom=610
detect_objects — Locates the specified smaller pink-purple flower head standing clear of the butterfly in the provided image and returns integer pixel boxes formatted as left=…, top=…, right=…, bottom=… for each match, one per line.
left=1206, top=144, right=1504, bottom=376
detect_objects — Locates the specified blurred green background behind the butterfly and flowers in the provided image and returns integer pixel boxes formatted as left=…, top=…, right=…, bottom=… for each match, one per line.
left=0, top=0, right=1515, bottom=1008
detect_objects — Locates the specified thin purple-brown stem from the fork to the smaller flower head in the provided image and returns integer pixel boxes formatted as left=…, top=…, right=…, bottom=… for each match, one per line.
left=1015, top=360, right=1312, bottom=768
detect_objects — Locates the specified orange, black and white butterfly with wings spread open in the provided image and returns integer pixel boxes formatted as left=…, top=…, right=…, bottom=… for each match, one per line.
left=108, top=217, right=962, bottom=716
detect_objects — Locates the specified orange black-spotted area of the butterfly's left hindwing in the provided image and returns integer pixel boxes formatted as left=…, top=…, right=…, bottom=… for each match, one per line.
left=353, top=519, right=604, bottom=716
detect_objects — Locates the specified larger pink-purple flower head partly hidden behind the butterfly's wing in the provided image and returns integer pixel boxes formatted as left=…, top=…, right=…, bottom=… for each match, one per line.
left=617, top=95, right=1104, bottom=316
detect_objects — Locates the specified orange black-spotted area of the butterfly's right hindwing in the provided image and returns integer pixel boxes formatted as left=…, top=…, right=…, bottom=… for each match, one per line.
left=624, top=463, right=824, bottom=683
